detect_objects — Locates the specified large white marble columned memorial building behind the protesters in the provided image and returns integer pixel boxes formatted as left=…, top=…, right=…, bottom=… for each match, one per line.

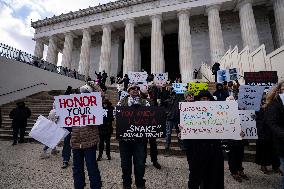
left=32, top=0, right=284, bottom=82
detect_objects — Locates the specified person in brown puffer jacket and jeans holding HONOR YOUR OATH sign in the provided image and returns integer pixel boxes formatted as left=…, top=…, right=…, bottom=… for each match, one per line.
left=71, top=83, right=102, bottom=189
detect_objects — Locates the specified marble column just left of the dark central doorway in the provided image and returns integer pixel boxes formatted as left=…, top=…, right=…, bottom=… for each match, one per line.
left=123, top=19, right=135, bottom=75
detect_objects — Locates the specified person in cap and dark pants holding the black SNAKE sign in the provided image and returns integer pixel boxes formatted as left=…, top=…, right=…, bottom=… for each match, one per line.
left=117, top=84, right=150, bottom=189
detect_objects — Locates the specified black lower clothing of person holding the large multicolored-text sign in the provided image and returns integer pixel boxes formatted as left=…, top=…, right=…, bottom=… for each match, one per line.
left=187, top=143, right=224, bottom=189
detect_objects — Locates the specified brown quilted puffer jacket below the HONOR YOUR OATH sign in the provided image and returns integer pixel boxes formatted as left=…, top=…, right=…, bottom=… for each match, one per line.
left=71, top=125, right=100, bottom=149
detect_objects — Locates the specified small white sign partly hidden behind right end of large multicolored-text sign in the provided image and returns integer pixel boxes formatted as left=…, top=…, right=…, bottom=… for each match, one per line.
left=239, top=110, right=258, bottom=139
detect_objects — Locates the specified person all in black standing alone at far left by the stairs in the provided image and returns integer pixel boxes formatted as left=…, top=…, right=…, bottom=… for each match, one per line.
left=9, top=102, right=31, bottom=145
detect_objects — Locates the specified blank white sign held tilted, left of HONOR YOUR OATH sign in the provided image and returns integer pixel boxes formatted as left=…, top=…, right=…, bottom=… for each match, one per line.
left=29, top=115, right=69, bottom=149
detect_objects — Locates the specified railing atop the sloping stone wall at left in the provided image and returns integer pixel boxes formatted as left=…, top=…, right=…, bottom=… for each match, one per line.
left=0, top=43, right=85, bottom=81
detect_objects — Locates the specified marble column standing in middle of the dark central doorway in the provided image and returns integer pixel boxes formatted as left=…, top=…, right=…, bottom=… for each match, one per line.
left=151, top=15, right=165, bottom=73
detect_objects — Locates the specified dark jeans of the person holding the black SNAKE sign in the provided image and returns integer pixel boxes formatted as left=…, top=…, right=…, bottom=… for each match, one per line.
left=119, top=141, right=146, bottom=187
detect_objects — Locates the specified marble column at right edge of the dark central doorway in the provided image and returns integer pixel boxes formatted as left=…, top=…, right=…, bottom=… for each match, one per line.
left=178, top=10, right=193, bottom=82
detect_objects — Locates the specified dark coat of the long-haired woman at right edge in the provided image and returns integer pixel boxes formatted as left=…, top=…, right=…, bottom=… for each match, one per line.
left=266, top=96, right=284, bottom=158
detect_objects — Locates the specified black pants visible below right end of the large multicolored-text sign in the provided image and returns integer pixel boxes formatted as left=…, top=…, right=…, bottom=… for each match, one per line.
left=228, top=141, right=244, bottom=174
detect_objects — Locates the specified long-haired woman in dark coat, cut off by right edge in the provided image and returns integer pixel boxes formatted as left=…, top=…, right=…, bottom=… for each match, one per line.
left=266, top=81, right=284, bottom=189
